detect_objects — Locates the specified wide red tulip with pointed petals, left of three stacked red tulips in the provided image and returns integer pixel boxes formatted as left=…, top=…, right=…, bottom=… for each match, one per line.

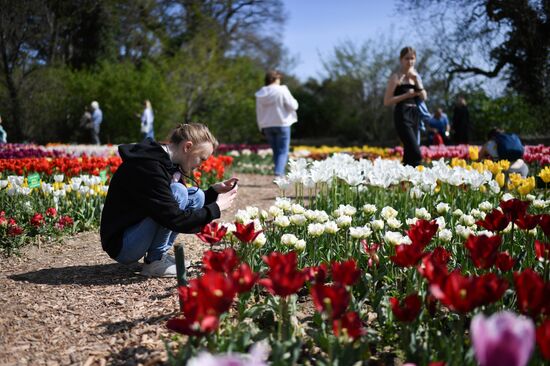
left=258, top=252, right=305, bottom=297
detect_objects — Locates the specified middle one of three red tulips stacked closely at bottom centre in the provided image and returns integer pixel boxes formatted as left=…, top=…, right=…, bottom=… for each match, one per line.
left=311, top=284, right=350, bottom=319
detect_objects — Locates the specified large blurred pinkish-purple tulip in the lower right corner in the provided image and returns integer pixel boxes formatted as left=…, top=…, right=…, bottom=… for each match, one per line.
left=470, top=311, right=535, bottom=366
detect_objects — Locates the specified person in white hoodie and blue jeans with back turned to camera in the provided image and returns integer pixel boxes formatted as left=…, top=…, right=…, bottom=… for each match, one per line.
left=256, top=71, right=298, bottom=176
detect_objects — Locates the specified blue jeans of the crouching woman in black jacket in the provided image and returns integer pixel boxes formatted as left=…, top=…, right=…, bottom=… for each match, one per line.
left=116, top=183, right=204, bottom=264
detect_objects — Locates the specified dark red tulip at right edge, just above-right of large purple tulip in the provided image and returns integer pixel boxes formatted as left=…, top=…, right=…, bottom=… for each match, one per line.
left=514, top=268, right=550, bottom=318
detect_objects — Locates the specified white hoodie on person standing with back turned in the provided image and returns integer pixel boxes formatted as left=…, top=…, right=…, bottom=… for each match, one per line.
left=256, top=84, right=298, bottom=130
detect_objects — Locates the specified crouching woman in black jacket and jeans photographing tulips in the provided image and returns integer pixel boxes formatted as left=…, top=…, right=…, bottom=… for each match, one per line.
left=100, top=123, right=237, bottom=277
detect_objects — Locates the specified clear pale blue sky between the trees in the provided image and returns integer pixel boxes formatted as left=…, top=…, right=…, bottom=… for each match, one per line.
left=283, top=0, right=408, bottom=81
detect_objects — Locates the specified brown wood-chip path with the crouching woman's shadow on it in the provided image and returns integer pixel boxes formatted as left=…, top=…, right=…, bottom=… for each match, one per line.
left=0, top=174, right=278, bottom=366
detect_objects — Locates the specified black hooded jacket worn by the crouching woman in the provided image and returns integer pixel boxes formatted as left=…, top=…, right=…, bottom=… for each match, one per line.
left=100, top=139, right=220, bottom=258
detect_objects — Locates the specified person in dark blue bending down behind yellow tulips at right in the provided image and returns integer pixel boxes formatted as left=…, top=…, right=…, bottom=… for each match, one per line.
left=479, top=127, right=529, bottom=178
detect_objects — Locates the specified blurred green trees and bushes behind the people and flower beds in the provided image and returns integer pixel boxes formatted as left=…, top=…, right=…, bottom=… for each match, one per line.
left=0, top=0, right=550, bottom=146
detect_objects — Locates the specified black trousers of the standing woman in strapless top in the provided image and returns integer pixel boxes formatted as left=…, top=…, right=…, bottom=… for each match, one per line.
left=393, top=104, right=422, bottom=166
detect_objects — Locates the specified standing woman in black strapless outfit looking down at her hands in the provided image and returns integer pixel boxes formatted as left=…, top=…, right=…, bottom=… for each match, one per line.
left=384, top=47, right=428, bottom=166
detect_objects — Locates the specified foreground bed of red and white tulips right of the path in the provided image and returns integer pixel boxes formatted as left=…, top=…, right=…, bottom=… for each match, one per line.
left=167, top=155, right=550, bottom=366
